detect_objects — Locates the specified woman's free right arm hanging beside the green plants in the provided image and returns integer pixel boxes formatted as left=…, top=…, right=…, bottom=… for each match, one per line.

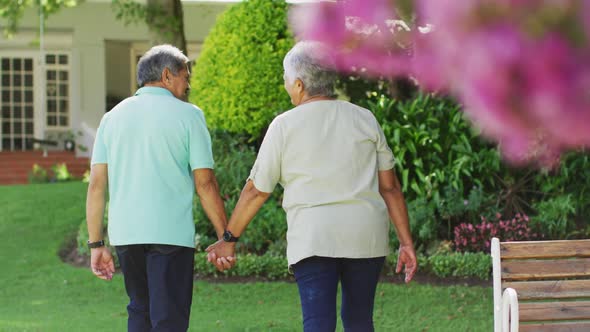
left=379, top=169, right=418, bottom=282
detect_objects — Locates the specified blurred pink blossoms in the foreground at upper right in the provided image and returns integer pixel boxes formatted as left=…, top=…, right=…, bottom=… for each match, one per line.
left=291, top=0, right=590, bottom=166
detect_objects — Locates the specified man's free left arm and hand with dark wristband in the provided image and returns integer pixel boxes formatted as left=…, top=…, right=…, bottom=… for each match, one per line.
left=86, top=164, right=115, bottom=280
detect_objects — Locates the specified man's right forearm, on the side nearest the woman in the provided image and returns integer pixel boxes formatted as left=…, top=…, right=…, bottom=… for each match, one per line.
left=193, top=168, right=227, bottom=239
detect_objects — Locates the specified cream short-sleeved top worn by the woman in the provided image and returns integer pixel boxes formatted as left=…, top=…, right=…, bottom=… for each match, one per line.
left=249, top=100, right=394, bottom=265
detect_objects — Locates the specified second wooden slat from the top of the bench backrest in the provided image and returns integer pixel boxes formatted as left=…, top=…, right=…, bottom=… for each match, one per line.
left=502, top=258, right=590, bottom=280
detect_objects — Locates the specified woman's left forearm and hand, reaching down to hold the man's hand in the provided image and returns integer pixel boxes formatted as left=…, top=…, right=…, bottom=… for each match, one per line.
left=207, top=180, right=270, bottom=271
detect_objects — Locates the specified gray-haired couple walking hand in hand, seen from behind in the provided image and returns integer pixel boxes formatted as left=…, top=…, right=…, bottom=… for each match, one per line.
left=87, top=41, right=417, bottom=331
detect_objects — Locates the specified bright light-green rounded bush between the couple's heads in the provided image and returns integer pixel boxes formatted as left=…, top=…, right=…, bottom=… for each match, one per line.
left=190, top=0, right=294, bottom=139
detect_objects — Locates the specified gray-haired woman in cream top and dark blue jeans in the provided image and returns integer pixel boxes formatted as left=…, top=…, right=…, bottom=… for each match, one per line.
left=207, top=42, right=416, bottom=331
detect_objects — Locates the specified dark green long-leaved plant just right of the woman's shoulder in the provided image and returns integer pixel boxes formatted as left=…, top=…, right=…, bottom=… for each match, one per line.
left=364, top=94, right=500, bottom=203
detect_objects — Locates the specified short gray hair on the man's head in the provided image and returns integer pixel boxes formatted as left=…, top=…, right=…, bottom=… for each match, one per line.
left=137, top=45, right=189, bottom=87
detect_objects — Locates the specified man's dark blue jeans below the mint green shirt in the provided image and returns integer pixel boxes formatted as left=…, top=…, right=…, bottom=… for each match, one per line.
left=115, top=244, right=194, bottom=332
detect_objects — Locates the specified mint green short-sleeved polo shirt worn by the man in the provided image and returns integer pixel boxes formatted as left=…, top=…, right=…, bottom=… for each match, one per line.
left=92, top=87, right=213, bottom=247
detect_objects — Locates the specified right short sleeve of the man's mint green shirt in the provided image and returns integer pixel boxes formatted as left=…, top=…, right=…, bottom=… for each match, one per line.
left=188, top=108, right=214, bottom=170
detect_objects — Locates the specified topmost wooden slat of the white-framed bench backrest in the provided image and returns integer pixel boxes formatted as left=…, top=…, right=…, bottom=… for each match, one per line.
left=500, top=240, right=590, bottom=260
